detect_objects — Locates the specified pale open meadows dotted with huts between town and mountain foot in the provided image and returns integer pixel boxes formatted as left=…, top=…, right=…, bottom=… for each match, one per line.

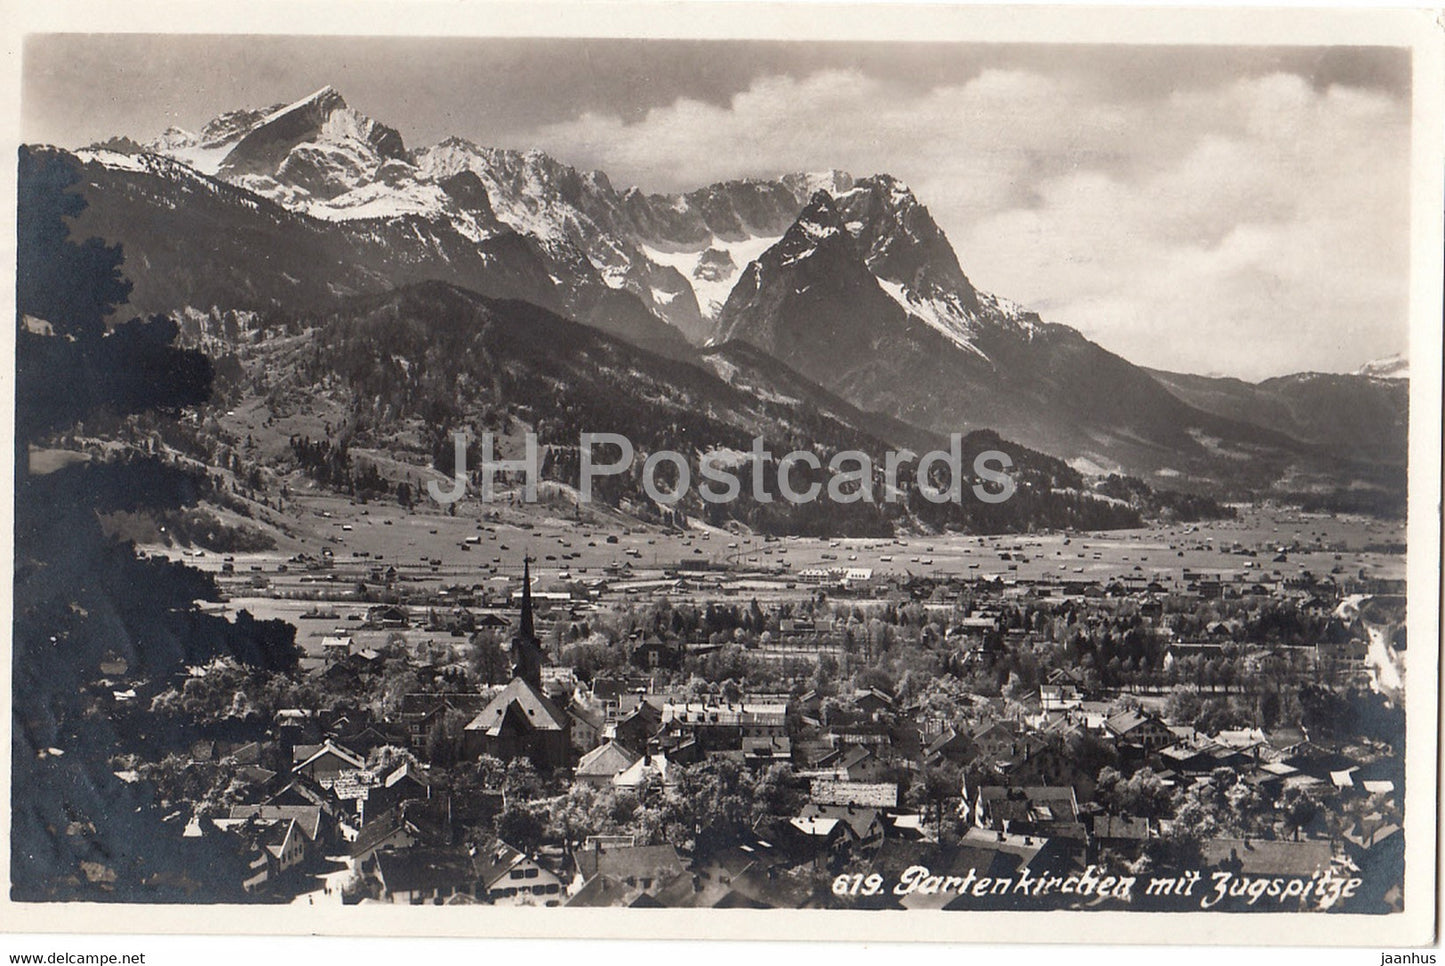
left=147, top=482, right=1405, bottom=654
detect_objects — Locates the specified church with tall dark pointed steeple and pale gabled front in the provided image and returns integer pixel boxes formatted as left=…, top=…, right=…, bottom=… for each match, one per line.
left=465, top=557, right=572, bottom=771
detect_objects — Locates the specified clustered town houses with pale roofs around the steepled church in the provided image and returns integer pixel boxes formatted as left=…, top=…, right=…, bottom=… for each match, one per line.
left=130, top=560, right=1403, bottom=908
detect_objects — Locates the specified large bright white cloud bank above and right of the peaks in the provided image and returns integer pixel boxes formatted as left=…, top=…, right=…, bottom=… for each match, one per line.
left=533, top=69, right=1409, bottom=377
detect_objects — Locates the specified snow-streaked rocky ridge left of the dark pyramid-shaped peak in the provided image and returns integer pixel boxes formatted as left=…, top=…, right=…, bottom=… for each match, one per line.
left=143, top=87, right=850, bottom=342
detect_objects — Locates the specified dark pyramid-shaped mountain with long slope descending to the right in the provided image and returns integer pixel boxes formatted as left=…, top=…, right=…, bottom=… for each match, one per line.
left=717, top=176, right=1404, bottom=502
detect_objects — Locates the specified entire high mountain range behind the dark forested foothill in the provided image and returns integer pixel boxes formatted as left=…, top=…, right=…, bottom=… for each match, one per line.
left=36, top=87, right=1407, bottom=508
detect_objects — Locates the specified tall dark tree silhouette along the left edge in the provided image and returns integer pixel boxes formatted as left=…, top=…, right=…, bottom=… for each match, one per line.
left=12, top=149, right=298, bottom=901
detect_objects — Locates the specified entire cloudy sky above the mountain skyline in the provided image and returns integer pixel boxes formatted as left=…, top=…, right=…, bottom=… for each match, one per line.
left=22, top=35, right=1410, bottom=380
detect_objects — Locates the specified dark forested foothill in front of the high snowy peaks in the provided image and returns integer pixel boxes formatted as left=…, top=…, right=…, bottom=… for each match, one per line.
left=254, top=282, right=1139, bottom=536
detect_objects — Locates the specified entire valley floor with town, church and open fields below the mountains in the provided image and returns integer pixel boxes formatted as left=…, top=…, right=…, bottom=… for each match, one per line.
left=36, top=470, right=1405, bottom=911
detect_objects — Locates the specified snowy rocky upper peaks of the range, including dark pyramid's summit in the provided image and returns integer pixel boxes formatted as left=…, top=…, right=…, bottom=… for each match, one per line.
left=130, top=85, right=1017, bottom=348
